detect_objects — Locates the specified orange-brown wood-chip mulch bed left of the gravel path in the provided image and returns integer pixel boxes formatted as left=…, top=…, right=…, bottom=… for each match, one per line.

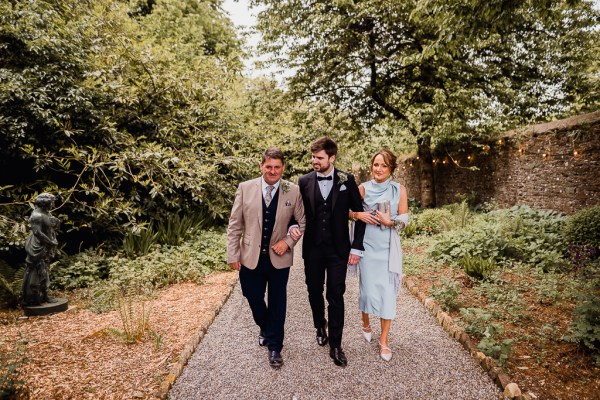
left=0, top=272, right=237, bottom=400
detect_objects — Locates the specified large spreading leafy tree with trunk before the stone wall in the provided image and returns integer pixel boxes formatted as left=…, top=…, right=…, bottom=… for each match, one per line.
left=251, top=0, right=600, bottom=206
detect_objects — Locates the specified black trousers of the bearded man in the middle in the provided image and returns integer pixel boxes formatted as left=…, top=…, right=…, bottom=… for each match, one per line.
left=304, top=244, right=348, bottom=348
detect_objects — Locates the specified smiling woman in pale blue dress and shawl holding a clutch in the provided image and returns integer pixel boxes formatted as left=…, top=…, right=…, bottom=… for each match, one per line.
left=350, top=149, right=408, bottom=361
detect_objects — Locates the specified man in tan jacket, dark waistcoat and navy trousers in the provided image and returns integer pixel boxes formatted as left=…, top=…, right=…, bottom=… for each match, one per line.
left=227, top=149, right=304, bottom=368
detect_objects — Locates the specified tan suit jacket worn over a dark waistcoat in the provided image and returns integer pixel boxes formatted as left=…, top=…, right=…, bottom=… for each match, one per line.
left=227, top=177, right=305, bottom=269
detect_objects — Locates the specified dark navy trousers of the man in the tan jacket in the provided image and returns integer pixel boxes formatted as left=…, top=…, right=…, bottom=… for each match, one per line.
left=240, top=255, right=290, bottom=351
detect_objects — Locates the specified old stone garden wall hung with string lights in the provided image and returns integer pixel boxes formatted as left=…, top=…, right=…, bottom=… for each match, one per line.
left=397, top=111, right=600, bottom=213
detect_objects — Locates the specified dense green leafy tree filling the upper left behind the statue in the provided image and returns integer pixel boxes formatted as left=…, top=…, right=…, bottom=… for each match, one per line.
left=0, top=0, right=248, bottom=255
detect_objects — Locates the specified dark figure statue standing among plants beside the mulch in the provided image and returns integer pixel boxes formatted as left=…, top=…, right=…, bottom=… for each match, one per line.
left=22, top=193, right=67, bottom=315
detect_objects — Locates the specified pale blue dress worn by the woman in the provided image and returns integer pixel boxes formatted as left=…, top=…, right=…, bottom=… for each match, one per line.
left=358, top=179, right=402, bottom=319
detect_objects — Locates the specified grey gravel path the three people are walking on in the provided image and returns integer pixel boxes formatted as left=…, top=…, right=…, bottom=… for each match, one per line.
left=169, top=248, right=502, bottom=400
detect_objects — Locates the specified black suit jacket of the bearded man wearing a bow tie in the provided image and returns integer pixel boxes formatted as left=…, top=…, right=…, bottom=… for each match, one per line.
left=298, top=169, right=366, bottom=259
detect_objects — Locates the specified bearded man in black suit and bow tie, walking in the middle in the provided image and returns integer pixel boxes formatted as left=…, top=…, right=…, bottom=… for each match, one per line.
left=290, top=137, right=365, bottom=367
